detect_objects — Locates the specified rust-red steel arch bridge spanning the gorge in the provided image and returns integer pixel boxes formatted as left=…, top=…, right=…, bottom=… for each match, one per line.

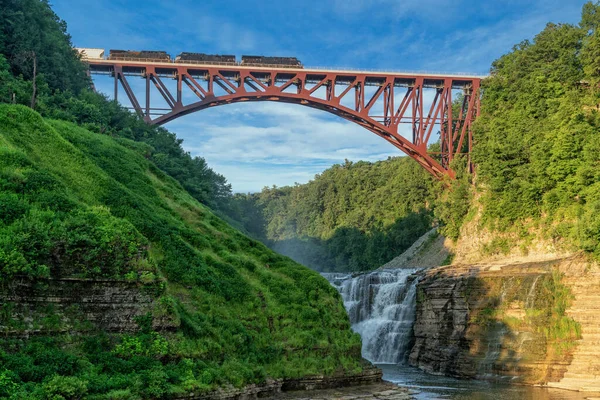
left=87, top=59, right=482, bottom=179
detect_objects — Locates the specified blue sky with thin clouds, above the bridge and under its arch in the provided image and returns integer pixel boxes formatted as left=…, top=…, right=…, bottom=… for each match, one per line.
left=52, top=0, right=585, bottom=192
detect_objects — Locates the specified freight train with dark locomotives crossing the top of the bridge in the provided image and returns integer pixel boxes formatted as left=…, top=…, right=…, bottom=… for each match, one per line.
left=75, top=48, right=303, bottom=68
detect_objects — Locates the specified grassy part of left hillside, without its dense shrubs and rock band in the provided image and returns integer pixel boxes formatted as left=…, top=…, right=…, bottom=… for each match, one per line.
left=0, top=105, right=360, bottom=397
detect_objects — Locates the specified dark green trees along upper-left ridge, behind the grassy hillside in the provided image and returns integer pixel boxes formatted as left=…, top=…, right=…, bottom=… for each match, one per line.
left=0, top=0, right=231, bottom=212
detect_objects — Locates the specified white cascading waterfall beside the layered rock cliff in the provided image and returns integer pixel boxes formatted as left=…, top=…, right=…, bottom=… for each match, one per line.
left=323, top=269, right=418, bottom=364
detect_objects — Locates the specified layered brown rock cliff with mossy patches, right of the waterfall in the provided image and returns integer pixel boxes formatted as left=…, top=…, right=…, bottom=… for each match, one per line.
left=410, top=261, right=580, bottom=383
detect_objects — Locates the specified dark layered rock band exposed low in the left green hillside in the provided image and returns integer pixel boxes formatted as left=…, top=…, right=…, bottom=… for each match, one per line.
left=0, top=279, right=172, bottom=336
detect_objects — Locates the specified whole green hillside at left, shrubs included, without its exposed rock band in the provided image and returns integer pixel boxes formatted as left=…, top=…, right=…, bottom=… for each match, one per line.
left=0, top=105, right=360, bottom=399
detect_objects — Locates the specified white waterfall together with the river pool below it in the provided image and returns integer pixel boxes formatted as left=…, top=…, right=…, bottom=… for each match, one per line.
left=323, top=269, right=589, bottom=400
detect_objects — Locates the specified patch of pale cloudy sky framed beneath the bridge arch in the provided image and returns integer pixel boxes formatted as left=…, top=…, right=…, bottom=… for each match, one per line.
left=167, top=102, right=402, bottom=191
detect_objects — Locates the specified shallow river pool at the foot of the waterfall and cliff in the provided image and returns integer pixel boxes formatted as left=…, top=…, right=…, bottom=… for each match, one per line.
left=377, top=364, right=597, bottom=400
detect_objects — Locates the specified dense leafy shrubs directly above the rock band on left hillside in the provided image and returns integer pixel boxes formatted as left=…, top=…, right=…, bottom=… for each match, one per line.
left=0, top=127, right=154, bottom=282
